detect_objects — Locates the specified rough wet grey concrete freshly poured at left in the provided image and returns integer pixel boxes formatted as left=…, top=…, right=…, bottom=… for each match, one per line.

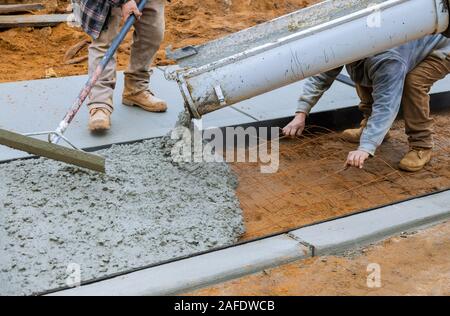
left=0, top=139, right=244, bottom=295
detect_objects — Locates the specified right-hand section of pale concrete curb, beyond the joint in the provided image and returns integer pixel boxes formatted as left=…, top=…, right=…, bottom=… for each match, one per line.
left=290, top=191, right=450, bottom=255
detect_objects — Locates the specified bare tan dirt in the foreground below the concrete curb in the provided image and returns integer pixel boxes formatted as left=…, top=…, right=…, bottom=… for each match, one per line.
left=188, top=222, right=450, bottom=296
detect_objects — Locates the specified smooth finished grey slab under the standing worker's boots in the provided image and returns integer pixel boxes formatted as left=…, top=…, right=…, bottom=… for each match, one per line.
left=0, top=69, right=450, bottom=162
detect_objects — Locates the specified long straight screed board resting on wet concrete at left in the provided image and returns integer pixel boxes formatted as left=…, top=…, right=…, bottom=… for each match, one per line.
left=0, top=129, right=106, bottom=173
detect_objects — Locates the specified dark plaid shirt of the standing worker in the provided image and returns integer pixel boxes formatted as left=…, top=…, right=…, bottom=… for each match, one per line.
left=76, top=0, right=128, bottom=39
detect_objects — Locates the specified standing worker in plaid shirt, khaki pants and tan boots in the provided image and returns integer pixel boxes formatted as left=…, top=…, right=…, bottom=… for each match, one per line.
left=79, top=0, right=167, bottom=132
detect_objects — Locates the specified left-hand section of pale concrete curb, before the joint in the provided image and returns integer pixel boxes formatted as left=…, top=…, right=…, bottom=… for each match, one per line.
left=48, top=235, right=312, bottom=296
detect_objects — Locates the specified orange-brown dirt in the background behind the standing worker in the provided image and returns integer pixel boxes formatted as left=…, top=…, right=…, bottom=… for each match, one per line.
left=0, top=0, right=320, bottom=82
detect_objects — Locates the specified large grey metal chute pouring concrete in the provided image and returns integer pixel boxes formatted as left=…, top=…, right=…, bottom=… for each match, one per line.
left=172, top=0, right=449, bottom=118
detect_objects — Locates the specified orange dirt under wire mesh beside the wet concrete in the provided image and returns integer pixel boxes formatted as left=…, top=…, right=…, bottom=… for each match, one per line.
left=233, top=113, right=450, bottom=240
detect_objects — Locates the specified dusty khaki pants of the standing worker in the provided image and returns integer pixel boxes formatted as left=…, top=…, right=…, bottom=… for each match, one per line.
left=88, top=0, right=165, bottom=112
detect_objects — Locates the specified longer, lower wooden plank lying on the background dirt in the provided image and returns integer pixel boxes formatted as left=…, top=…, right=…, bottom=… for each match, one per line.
left=0, top=14, right=69, bottom=28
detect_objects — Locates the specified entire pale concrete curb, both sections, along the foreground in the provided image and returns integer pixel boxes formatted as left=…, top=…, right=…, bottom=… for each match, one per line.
left=52, top=191, right=450, bottom=296
